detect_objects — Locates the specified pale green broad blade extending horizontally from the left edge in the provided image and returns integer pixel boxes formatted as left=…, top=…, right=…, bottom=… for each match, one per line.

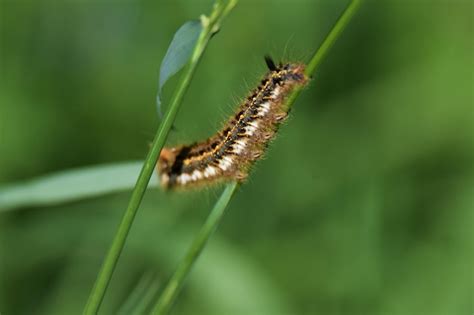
left=0, top=161, right=158, bottom=211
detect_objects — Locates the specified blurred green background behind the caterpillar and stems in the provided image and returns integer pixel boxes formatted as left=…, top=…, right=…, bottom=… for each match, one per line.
left=0, top=0, right=474, bottom=315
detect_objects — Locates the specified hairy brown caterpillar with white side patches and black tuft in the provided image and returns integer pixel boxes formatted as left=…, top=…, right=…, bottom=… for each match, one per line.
left=157, top=56, right=309, bottom=189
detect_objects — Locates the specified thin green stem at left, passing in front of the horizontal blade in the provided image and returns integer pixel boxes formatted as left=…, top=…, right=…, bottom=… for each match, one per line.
left=83, top=0, right=236, bottom=315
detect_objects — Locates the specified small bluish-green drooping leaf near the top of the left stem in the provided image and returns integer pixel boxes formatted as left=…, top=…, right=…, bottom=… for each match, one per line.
left=156, top=20, right=202, bottom=117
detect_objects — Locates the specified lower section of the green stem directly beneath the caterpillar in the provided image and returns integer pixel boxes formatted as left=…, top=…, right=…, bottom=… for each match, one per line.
left=151, top=182, right=239, bottom=315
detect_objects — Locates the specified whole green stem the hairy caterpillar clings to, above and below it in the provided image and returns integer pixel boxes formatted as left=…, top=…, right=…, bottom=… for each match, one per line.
left=151, top=0, right=360, bottom=315
